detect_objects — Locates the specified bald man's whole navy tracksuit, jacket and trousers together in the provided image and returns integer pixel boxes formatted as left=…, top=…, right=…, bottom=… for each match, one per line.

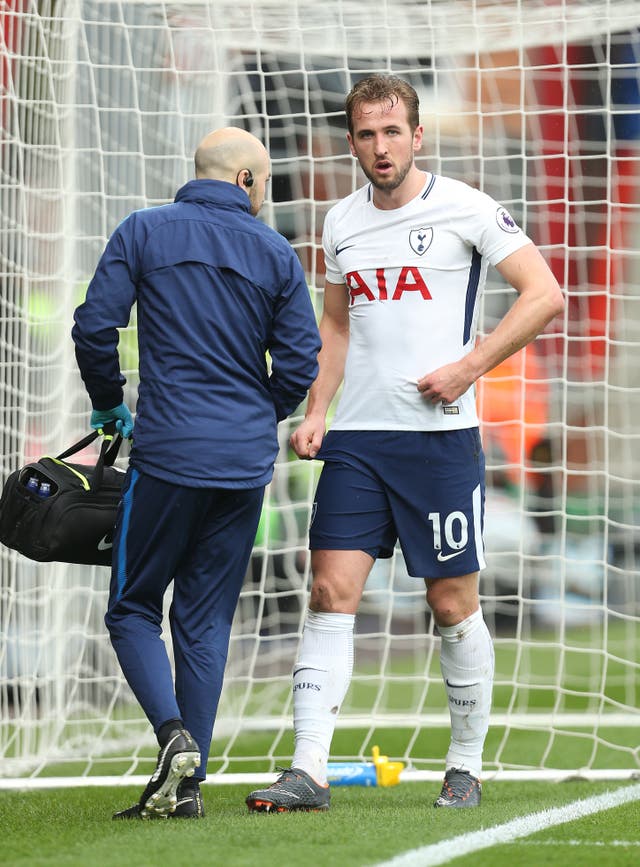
left=72, top=180, right=320, bottom=780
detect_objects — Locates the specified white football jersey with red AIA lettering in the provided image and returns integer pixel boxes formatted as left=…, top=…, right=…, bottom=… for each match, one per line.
left=323, top=173, right=531, bottom=430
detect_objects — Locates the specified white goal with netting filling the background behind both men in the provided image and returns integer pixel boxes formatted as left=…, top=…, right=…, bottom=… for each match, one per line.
left=0, top=0, right=640, bottom=787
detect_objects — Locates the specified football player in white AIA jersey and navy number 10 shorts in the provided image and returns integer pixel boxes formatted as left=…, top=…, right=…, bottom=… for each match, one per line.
left=246, top=75, right=564, bottom=812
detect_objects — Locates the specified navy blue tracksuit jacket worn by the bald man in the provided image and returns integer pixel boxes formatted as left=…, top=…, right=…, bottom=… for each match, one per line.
left=72, top=180, right=320, bottom=488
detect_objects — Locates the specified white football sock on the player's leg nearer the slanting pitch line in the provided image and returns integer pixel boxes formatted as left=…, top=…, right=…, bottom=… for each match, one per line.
left=438, top=608, right=494, bottom=778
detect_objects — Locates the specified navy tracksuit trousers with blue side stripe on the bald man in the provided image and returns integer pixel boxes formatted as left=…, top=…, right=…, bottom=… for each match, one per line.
left=105, top=467, right=264, bottom=779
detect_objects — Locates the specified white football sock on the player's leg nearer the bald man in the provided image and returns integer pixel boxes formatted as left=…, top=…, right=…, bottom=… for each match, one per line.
left=292, top=611, right=355, bottom=785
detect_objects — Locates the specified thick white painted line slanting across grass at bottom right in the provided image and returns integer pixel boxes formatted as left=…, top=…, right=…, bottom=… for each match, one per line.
left=376, top=783, right=640, bottom=867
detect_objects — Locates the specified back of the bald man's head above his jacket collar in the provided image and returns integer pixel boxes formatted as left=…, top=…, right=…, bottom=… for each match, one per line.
left=195, top=126, right=269, bottom=184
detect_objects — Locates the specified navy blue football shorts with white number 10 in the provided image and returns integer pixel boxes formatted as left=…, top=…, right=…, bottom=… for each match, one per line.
left=309, top=427, right=485, bottom=578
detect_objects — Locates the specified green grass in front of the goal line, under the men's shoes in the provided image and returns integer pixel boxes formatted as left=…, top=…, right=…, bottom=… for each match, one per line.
left=0, top=781, right=640, bottom=867
